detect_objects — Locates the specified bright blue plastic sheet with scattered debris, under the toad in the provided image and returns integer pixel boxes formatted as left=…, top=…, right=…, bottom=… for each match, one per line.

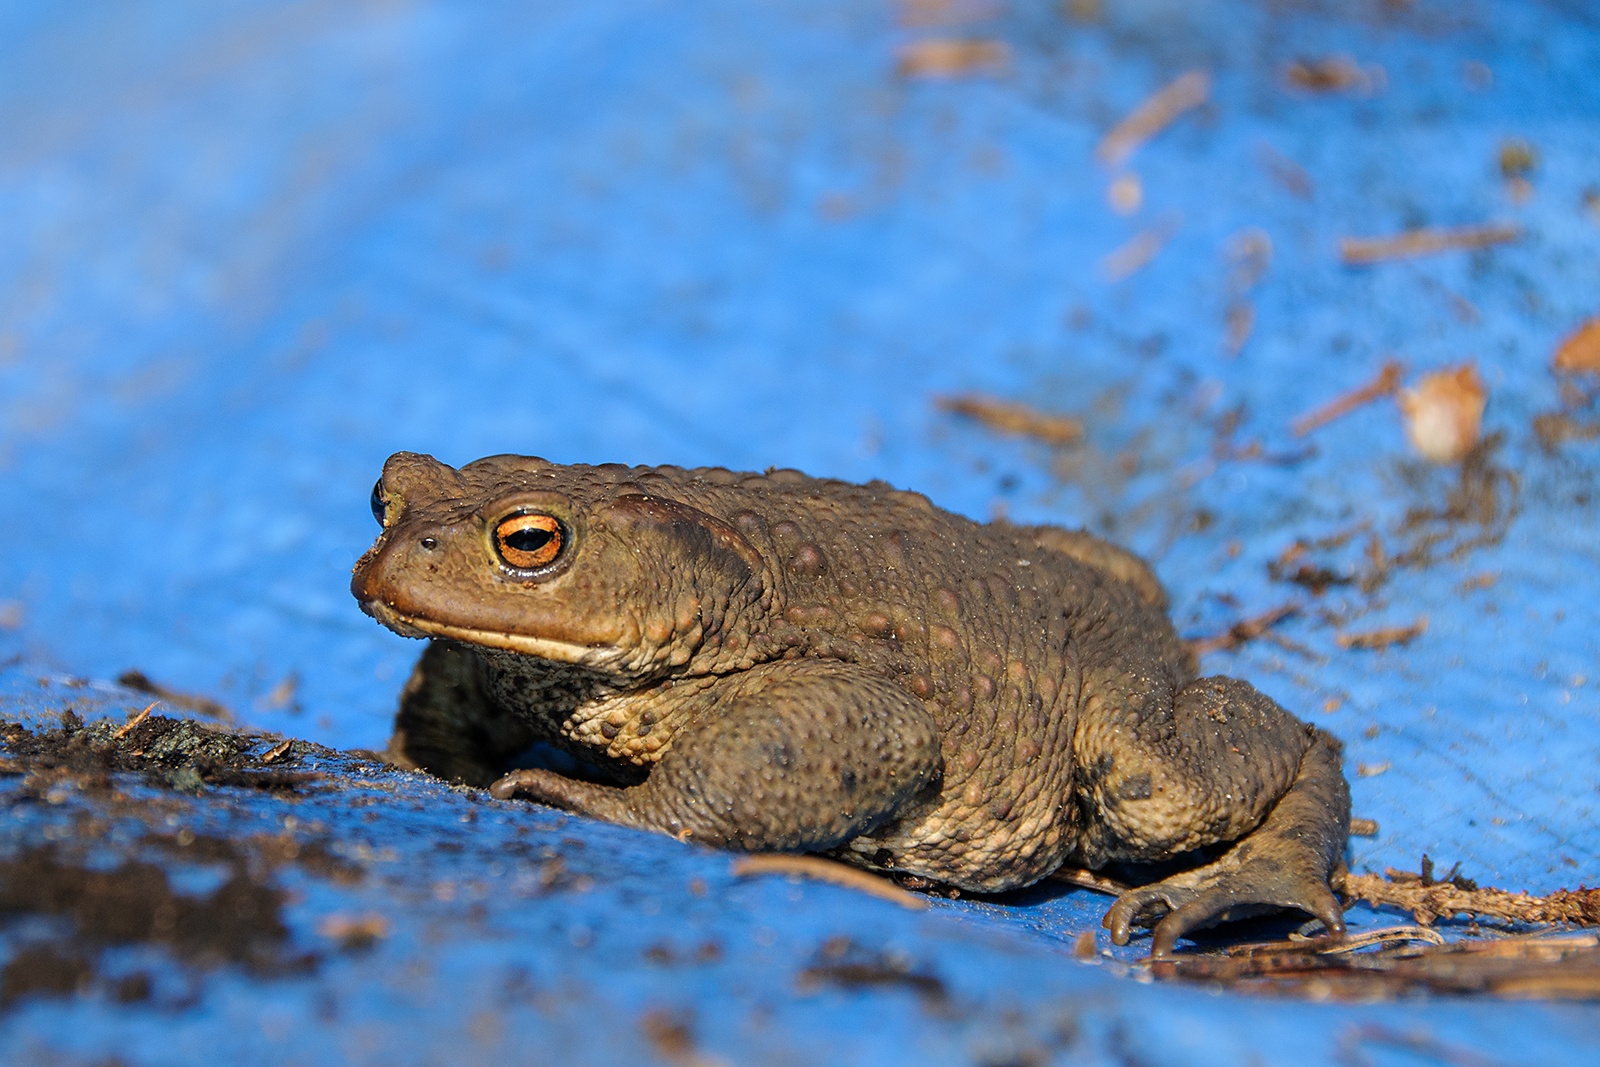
left=0, top=0, right=1600, bottom=1064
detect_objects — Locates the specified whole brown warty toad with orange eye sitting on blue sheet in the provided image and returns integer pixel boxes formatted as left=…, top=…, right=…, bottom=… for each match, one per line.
left=352, top=453, right=1349, bottom=953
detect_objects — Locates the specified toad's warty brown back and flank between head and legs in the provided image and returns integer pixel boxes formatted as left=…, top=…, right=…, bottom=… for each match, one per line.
left=617, top=470, right=1194, bottom=888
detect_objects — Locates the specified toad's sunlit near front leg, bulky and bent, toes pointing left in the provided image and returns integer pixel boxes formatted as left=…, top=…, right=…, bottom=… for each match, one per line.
left=491, top=659, right=942, bottom=851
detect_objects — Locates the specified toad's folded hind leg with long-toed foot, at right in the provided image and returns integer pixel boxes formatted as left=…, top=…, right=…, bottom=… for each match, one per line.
left=1080, top=678, right=1350, bottom=955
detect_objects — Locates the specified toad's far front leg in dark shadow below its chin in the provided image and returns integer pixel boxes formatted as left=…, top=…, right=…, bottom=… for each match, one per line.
left=384, top=641, right=533, bottom=785
